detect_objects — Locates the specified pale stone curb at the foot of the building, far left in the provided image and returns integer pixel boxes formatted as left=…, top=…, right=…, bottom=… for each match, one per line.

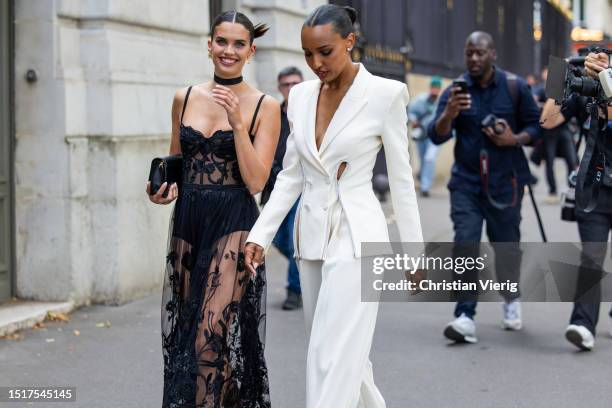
left=0, top=300, right=75, bottom=337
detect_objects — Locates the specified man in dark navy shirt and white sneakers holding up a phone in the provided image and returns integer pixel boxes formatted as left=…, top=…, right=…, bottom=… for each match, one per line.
left=428, top=31, right=541, bottom=343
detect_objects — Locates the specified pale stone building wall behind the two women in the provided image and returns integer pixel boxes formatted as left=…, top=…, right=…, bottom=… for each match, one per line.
left=0, top=0, right=322, bottom=304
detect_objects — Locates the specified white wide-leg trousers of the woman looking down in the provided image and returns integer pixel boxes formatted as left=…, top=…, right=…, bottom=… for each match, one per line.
left=299, top=203, right=385, bottom=408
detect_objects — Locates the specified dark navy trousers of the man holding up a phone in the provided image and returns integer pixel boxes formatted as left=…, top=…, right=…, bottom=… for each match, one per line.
left=450, top=186, right=523, bottom=319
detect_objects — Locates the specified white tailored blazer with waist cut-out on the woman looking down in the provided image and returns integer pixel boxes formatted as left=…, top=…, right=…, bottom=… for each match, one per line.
left=247, top=64, right=423, bottom=260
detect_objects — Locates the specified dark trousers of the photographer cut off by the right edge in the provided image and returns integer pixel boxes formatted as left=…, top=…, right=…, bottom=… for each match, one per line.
left=570, top=207, right=612, bottom=335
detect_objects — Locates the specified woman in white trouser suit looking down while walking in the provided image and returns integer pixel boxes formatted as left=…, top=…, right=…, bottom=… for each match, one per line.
left=245, top=5, right=422, bottom=408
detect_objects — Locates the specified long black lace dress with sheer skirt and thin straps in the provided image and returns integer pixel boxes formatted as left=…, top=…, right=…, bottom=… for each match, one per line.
left=162, top=87, right=270, bottom=408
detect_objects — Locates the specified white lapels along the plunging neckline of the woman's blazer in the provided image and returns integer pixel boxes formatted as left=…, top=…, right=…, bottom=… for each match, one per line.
left=312, top=64, right=372, bottom=157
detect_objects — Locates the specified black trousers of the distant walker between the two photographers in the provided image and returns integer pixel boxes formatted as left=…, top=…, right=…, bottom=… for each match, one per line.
left=544, top=126, right=578, bottom=194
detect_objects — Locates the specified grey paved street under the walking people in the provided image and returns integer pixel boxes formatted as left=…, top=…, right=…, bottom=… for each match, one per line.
left=0, top=172, right=612, bottom=408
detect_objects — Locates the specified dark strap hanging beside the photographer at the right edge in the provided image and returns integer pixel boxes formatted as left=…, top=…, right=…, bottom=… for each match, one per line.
left=576, top=103, right=606, bottom=213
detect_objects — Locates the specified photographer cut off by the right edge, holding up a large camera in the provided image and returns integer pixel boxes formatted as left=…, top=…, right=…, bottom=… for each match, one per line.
left=541, top=52, right=612, bottom=350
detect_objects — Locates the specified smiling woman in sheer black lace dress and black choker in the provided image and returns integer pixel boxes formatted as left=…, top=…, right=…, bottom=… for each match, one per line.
left=147, top=11, right=280, bottom=408
